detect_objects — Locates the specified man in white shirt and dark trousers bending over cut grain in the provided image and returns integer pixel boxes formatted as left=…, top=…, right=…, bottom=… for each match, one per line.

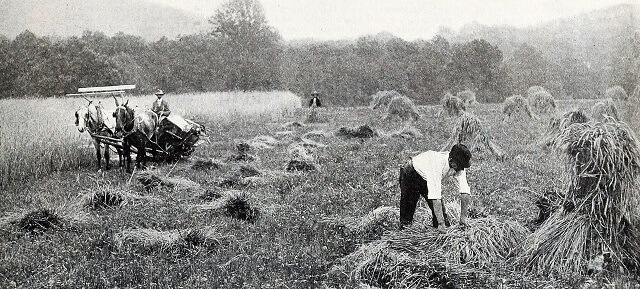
left=400, top=143, right=471, bottom=233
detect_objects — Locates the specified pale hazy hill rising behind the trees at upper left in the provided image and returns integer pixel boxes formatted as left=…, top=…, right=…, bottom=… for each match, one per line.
left=0, top=0, right=208, bottom=41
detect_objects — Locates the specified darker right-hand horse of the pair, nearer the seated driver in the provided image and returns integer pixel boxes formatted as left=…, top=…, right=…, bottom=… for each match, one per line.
left=113, top=96, right=158, bottom=172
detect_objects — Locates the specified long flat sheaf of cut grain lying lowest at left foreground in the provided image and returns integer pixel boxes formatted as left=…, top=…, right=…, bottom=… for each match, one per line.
left=114, top=227, right=226, bottom=252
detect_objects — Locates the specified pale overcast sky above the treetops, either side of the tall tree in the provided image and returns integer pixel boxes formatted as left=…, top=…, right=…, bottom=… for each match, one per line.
left=147, top=0, right=640, bottom=40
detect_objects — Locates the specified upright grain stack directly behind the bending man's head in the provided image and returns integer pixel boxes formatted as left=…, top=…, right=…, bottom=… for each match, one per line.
left=442, top=112, right=505, bottom=159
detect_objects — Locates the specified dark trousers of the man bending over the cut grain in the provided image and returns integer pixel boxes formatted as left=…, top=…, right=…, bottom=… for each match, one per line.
left=399, top=161, right=450, bottom=227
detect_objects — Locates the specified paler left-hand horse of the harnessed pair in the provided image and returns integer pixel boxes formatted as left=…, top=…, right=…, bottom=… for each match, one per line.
left=75, top=100, right=123, bottom=170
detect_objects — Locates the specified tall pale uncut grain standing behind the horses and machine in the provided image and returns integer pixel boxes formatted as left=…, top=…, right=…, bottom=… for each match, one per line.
left=0, top=92, right=301, bottom=187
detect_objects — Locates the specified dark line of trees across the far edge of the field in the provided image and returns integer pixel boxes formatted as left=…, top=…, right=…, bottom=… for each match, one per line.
left=0, top=0, right=632, bottom=105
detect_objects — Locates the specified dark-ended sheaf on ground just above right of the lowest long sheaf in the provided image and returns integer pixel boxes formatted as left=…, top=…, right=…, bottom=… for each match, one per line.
left=195, top=191, right=260, bottom=222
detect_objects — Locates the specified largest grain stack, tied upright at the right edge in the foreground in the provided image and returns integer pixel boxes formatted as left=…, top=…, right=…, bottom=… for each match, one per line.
left=518, top=121, right=640, bottom=277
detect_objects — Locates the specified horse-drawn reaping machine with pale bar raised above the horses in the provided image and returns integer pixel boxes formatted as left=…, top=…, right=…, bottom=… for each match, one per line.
left=68, top=85, right=206, bottom=160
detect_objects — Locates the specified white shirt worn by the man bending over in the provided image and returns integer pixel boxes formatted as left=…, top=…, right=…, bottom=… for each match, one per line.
left=411, top=151, right=471, bottom=199
